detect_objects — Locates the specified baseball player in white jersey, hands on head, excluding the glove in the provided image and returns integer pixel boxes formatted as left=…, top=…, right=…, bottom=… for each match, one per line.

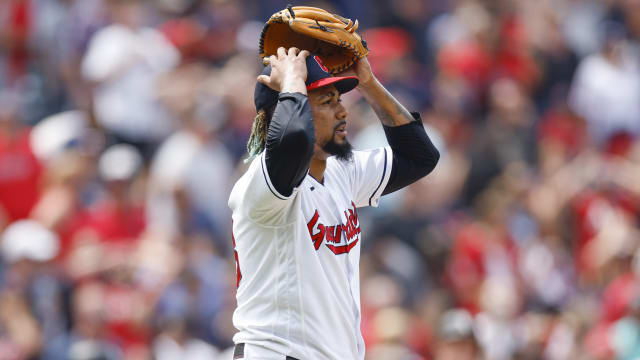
left=229, top=47, right=440, bottom=360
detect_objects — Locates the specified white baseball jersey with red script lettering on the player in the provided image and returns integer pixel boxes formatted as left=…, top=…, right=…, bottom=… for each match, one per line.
left=229, top=147, right=392, bottom=360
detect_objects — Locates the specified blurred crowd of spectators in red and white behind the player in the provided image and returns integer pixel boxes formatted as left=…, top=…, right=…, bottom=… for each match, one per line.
left=0, top=0, right=640, bottom=360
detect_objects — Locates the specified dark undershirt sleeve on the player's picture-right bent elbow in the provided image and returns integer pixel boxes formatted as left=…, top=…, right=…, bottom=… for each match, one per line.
left=382, top=113, right=440, bottom=195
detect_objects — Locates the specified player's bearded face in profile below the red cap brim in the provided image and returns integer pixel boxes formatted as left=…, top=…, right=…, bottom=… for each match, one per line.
left=309, top=85, right=351, bottom=159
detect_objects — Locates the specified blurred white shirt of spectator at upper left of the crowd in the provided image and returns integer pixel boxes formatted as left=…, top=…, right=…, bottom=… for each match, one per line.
left=82, top=24, right=180, bottom=141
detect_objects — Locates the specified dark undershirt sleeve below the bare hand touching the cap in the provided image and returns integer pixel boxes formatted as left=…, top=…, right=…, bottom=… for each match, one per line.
left=265, top=93, right=315, bottom=196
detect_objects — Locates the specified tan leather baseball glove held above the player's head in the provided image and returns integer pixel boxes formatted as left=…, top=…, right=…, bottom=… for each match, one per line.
left=260, top=6, right=369, bottom=74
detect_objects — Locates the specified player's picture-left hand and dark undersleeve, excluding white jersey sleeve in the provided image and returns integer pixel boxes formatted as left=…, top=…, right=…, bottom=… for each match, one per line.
left=258, top=48, right=315, bottom=197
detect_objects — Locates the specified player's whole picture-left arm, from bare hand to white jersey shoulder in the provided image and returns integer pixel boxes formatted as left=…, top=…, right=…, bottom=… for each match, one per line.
left=229, top=48, right=315, bottom=226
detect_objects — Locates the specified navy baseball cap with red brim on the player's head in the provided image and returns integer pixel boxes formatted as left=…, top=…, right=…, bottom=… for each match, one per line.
left=253, top=54, right=358, bottom=111
